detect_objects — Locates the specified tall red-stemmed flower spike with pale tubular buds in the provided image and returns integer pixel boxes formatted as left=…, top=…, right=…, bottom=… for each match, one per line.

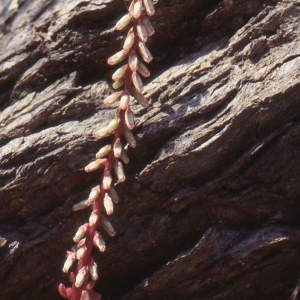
left=58, top=0, right=155, bottom=300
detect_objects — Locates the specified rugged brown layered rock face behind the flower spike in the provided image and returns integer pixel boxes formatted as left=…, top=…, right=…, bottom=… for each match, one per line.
left=0, top=0, right=300, bottom=300
